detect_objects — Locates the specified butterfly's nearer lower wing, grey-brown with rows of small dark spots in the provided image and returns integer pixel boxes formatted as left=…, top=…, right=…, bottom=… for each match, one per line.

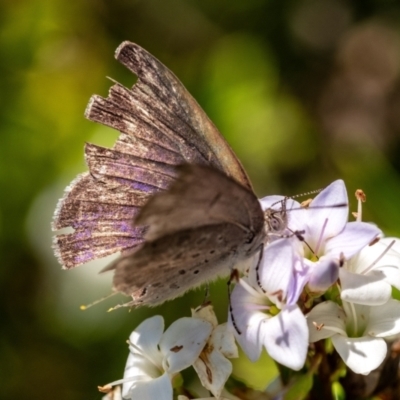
left=111, top=224, right=252, bottom=306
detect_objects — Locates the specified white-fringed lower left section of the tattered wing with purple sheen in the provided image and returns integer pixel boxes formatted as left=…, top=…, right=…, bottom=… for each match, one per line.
left=53, top=174, right=146, bottom=268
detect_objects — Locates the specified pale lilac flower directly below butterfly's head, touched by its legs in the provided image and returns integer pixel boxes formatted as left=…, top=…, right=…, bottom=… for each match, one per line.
left=229, top=239, right=308, bottom=370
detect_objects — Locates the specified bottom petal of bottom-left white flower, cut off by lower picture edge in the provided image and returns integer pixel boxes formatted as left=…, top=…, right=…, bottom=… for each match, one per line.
left=128, top=373, right=173, bottom=400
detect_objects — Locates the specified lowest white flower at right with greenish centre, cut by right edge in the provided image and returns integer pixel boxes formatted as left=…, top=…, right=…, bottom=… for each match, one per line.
left=307, top=300, right=400, bottom=375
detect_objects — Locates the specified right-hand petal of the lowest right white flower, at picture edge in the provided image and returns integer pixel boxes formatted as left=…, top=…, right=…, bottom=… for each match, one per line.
left=365, top=299, right=400, bottom=337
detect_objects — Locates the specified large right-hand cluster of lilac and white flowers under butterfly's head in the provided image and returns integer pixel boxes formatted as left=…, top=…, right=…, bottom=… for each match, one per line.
left=244, top=180, right=400, bottom=374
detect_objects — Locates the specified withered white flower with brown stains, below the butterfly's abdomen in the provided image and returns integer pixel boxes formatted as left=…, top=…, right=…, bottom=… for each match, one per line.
left=192, top=305, right=238, bottom=399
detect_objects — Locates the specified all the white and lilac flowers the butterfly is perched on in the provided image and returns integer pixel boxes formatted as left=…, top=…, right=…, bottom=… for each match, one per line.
left=101, top=180, right=400, bottom=400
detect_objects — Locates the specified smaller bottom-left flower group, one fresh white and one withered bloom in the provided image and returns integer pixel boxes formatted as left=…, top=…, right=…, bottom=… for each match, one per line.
left=99, top=305, right=238, bottom=400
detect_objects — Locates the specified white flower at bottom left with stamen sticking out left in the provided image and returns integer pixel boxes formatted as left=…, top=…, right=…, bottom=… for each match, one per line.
left=100, top=315, right=212, bottom=400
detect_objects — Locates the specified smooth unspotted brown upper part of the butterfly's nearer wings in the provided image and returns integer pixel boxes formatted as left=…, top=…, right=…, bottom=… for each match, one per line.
left=135, top=164, right=264, bottom=240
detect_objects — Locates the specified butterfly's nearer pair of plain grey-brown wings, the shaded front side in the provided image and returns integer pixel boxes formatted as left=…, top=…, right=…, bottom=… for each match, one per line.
left=107, top=165, right=265, bottom=305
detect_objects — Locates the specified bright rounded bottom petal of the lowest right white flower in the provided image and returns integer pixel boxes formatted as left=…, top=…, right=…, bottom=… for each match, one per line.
left=332, top=335, right=387, bottom=375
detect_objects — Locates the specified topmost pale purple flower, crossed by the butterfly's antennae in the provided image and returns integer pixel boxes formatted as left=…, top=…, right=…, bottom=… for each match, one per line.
left=261, top=180, right=381, bottom=293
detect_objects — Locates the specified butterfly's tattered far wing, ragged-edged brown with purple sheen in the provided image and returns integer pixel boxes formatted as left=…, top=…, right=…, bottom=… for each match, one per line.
left=53, top=42, right=251, bottom=268
